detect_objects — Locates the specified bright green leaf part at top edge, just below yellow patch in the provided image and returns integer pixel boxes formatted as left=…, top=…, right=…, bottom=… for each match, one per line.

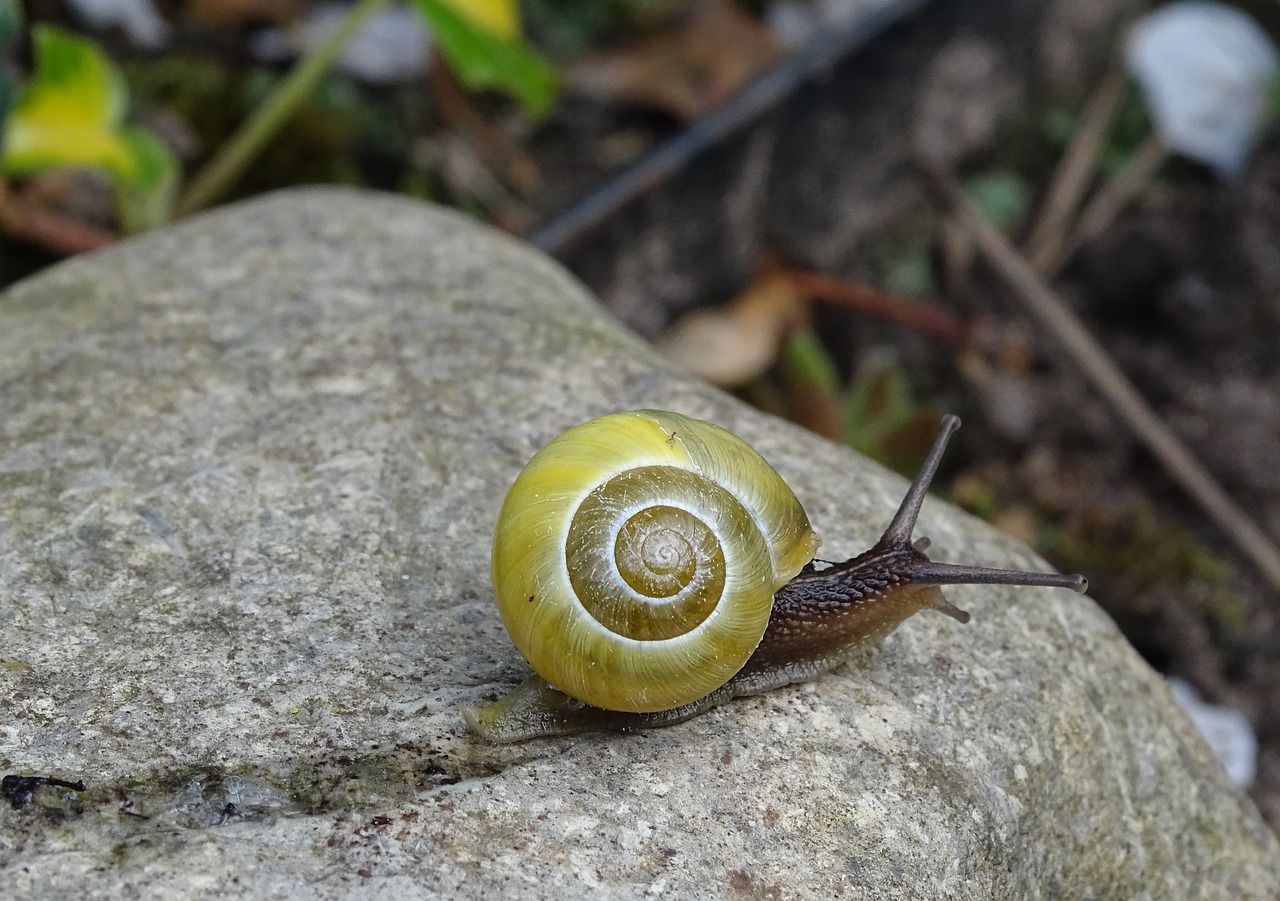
left=413, top=0, right=559, bottom=116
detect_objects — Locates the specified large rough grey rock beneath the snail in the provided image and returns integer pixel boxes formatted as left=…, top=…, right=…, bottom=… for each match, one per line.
left=0, top=189, right=1280, bottom=900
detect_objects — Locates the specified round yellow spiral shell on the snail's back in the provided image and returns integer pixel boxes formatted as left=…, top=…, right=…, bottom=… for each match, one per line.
left=493, top=410, right=818, bottom=713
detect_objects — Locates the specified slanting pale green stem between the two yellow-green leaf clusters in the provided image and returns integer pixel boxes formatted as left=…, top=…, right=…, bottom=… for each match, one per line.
left=177, top=0, right=392, bottom=216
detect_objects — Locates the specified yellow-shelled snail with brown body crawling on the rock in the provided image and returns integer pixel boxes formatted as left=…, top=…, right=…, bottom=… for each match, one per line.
left=463, top=410, right=1088, bottom=742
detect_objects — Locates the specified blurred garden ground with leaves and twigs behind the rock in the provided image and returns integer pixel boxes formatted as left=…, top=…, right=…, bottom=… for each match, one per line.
left=0, top=0, right=1280, bottom=827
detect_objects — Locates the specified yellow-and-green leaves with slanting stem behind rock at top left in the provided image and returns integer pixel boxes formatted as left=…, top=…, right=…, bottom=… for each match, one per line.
left=0, top=0, right=559, bottom=232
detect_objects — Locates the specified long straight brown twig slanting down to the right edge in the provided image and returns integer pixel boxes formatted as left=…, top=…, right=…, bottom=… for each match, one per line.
left=932, top=173, right=1280, bottom=591
